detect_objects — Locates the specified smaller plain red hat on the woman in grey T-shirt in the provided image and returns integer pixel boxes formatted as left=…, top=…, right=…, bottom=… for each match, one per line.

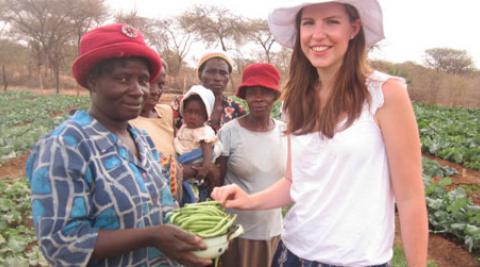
left=236, top=63, right=280, bottom=99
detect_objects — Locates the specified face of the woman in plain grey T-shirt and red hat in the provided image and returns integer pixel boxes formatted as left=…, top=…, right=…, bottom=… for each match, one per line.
left=243, top=86, right=279, bottom=118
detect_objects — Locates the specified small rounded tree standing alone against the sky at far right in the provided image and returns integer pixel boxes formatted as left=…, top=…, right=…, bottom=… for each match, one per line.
left=425, top=48, right=474, bottom=74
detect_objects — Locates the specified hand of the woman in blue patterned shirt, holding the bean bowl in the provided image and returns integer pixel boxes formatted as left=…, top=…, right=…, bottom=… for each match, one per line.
left=152, top=224, right=212, bottom=266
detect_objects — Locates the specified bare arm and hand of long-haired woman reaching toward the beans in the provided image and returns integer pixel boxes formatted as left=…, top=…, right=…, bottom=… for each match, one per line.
left=211, top=138, right=293, bottom=210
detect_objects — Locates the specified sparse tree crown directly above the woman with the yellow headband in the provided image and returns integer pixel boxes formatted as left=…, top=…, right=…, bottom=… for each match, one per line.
left=178, top=6, right=245, bottom=51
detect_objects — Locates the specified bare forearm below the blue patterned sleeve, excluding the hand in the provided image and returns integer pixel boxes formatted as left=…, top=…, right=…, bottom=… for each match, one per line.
left=92, top=228, right=152, bottom=260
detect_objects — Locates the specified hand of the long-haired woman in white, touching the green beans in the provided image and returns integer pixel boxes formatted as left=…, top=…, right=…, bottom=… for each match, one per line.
left=210, top=184, right=252, bottom=209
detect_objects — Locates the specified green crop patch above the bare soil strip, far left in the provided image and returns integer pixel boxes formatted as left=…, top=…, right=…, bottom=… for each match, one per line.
left=0, top=92, right=89, bottom=164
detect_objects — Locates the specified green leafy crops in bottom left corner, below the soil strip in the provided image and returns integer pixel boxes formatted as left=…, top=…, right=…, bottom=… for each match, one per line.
left=0, top=178, right=48, bottom=266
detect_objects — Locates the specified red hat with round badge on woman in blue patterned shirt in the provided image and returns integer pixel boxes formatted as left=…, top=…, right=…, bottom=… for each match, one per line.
left=72, top=24, right=162, bottom=88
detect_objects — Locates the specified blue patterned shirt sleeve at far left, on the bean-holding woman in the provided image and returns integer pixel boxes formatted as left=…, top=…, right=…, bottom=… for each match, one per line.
left=27, top=136, right=98, bottom=266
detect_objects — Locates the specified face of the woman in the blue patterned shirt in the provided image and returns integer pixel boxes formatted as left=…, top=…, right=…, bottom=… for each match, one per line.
left=87, top=58, right=150, bottom=122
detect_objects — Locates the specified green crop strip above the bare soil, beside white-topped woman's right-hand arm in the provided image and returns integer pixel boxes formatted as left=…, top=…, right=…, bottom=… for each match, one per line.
left=414, top=104, right=480, bottom=170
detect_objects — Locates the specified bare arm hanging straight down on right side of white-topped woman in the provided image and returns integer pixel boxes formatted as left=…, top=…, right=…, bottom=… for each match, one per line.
left=376, top=80, right=428, bottom=267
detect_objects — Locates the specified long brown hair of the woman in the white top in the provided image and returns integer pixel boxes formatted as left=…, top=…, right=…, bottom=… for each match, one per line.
left=283, top=4, right=370, bottom=138
